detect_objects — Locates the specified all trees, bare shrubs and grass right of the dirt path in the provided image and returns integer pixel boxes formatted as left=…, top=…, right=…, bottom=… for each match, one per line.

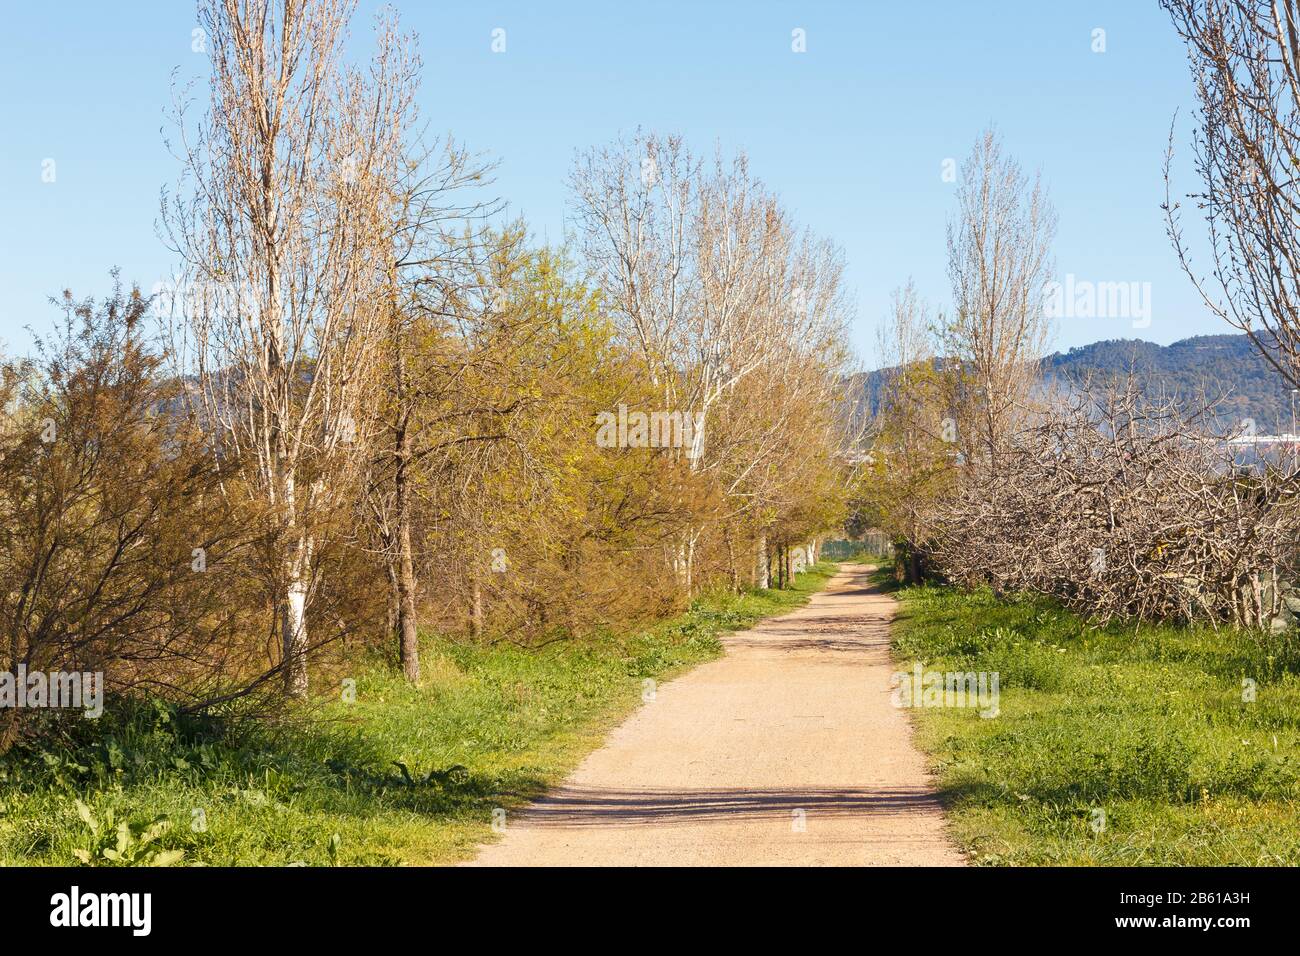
left=850, top=0, right=1300, bottom=865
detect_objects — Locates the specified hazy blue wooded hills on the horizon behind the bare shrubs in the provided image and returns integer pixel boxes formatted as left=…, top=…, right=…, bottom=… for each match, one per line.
left=861, top=334, right=1300, bottom=434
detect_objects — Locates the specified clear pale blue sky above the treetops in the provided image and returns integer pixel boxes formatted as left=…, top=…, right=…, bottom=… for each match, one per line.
left=0, top=0, right=1229, bottom=363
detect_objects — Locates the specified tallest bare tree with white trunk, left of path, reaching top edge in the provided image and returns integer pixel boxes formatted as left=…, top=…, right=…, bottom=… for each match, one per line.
left=164, top=0, right=417, bottom=696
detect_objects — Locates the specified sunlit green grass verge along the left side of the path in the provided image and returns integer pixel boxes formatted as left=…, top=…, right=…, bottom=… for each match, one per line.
left=0, top=564, right=835, bottom=865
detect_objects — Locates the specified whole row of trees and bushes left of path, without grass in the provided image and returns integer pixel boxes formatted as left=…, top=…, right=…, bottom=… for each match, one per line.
left=0, top=0, right=848, bottom=733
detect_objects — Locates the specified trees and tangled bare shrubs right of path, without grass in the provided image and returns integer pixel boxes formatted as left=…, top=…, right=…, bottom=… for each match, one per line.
left=858, top=0, right=1300, bottom=627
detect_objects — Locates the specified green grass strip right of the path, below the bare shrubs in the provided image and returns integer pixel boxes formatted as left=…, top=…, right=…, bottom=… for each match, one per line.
left=893, top=574, right=1300, bottom=866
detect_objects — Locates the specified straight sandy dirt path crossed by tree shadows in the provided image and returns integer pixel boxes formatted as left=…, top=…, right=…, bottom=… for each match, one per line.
left=476, top=566, right=962, bottom=866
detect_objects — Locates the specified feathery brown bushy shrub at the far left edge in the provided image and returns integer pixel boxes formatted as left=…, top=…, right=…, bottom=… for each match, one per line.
left=0, top=284, right=256, bottom=750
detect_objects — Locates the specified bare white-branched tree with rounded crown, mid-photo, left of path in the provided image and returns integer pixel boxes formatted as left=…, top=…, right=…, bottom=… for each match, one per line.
left=571, top=134, right=846, bottom=593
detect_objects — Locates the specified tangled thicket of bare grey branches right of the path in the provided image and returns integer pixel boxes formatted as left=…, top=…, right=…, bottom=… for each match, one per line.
left=933, top=389, right=1300, bottom=627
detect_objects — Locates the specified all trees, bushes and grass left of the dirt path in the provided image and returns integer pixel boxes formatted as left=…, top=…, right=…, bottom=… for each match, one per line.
left=0, top=0, right=853, bottom=865
